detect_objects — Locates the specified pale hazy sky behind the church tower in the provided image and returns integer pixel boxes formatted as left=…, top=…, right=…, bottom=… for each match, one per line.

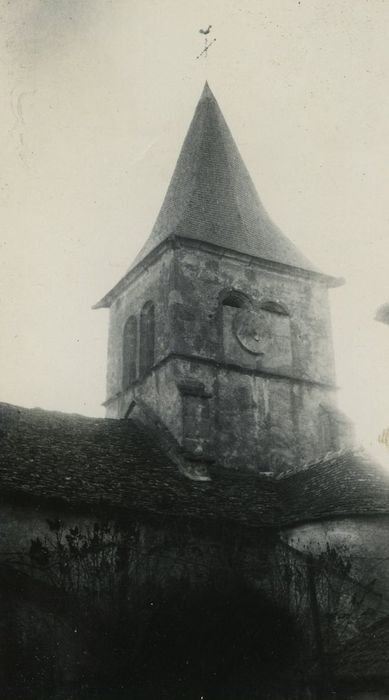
left=0, top=0, right=389, bottom=442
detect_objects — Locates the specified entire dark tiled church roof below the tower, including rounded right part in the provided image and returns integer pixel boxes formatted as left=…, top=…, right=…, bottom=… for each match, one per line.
left=0, top=404, right=389, bottom=528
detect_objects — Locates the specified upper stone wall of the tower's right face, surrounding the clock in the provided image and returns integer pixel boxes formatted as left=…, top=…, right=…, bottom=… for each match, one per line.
left=171, top=246, right=335, bottom=384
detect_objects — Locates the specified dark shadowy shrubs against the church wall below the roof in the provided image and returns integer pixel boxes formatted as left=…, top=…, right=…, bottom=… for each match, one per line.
left=0, top=521, right=382, bottom=700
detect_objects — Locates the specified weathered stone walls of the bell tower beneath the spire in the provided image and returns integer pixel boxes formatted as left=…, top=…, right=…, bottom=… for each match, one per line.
left=107, top=243, right=347, bottom=471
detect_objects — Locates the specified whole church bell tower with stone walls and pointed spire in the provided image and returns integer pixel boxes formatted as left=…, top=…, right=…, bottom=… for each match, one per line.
left=95, top=84, right=350, bottom=472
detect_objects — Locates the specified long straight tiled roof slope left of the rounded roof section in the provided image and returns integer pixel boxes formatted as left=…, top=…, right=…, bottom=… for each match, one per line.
left=0, top=404, right=280, bottom=527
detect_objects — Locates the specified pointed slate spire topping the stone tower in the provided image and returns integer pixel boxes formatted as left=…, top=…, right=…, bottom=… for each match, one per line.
left=131, top=83, right=315, bottom=271
